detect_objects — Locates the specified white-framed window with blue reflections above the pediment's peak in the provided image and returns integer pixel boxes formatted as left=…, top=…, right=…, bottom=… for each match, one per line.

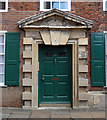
left=40, top=0, right=71, bottom=11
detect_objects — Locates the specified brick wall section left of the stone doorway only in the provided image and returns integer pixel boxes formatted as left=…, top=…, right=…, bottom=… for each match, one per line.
left=2, top=2, right=39, bottom=107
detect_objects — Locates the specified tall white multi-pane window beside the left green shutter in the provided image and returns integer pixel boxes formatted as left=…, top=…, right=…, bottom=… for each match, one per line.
left=0, top=31, right=6, bottom=86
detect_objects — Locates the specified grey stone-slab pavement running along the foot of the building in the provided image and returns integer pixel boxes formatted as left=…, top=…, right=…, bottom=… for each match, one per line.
left=0, top=107, right=107, bottom=120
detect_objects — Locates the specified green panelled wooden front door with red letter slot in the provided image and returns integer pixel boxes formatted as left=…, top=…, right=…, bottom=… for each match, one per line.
left=39, top=45, right=72, bottom=103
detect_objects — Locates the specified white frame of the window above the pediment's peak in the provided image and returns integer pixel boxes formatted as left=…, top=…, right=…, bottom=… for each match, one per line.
left=40, top=0, right=71, bottom=11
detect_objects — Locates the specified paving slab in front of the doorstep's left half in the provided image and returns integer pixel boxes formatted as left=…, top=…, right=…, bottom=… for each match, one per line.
left=30, top=110, right=51, bottom=118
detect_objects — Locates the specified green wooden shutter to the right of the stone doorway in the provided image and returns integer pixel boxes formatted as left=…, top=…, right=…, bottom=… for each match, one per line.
left=91, top=33, right=105, bottom=86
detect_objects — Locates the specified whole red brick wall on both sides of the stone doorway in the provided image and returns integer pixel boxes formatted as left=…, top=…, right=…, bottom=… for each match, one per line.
left=2, top=2, right=107, bottom=107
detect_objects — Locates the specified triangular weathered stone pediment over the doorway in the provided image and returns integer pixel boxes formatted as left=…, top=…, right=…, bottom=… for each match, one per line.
left=18, top=9, right=93, bottom=28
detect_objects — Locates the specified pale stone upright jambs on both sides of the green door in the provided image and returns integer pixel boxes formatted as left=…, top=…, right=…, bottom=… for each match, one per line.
left=32, top=40, right=79, bottom=108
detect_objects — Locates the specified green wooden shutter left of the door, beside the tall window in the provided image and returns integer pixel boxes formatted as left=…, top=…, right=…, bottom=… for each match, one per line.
left=5, top=33, right=20, bottom=86
